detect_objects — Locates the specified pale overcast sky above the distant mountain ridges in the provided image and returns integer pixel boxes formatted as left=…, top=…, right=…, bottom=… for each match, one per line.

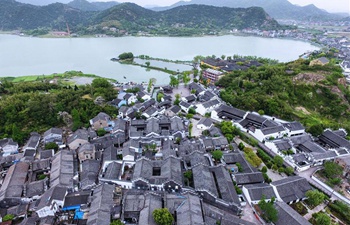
left=98, top=0, right=350, bottom=12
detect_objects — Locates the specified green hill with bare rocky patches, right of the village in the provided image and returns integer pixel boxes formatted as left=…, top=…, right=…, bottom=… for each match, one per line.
left=217, top=59, right=350, bottom=135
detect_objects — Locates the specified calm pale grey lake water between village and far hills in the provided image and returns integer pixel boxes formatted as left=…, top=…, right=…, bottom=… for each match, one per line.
left=0, top=35, right=318, bottom=84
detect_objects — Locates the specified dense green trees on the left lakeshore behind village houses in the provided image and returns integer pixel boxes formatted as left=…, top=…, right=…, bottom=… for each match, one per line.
left=0, top=72, right=118, bottom=143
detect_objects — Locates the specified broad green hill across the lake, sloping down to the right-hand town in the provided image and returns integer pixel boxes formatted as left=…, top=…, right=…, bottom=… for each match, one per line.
left=94, top=3, right=280, bottom=35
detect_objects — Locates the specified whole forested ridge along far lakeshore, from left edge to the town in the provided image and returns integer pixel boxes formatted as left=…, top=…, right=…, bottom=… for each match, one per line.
left=0, top=0, right=280, bottom=35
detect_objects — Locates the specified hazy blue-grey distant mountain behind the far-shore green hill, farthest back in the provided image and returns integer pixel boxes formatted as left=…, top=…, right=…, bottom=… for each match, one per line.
left=153, top=0, right=337, bottom=20
